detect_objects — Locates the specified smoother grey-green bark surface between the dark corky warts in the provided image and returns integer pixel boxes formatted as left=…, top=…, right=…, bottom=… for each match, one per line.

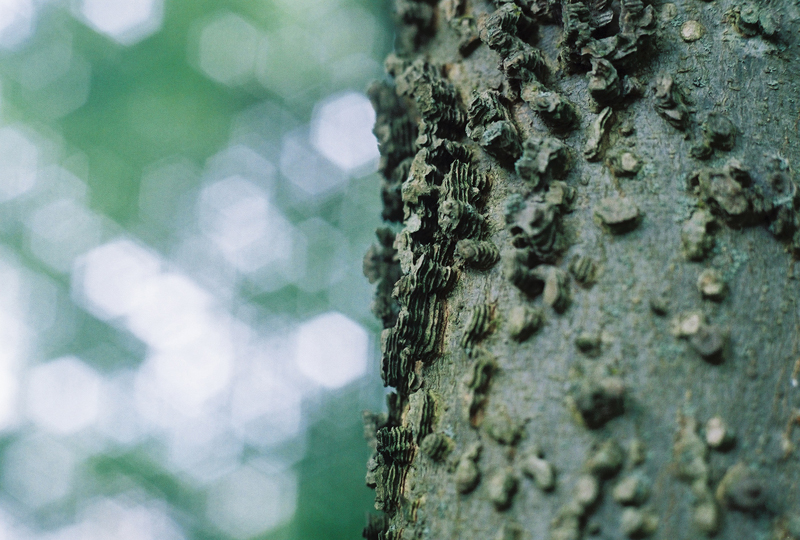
left=365, top=0, right=800, bottom=540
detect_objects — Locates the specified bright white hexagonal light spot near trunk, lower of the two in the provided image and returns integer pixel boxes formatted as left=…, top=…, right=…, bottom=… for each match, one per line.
left=295, top=311, right=369, bottom=388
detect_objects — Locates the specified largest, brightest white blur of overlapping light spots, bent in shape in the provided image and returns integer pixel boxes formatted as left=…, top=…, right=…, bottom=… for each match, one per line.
left=73, top=239, right=235, bottom=420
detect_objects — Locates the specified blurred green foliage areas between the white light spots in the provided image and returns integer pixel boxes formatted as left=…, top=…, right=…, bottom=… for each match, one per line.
left=0, top=0, right=391, bottom=539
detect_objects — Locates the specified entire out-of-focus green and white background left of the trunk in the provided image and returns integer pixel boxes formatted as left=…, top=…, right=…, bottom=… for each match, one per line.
left=0, top=0, right=392, bottom=540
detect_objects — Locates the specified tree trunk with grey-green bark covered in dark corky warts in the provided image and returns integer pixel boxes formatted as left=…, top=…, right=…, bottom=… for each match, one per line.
left=365, top=0, right=800, bottom=540
